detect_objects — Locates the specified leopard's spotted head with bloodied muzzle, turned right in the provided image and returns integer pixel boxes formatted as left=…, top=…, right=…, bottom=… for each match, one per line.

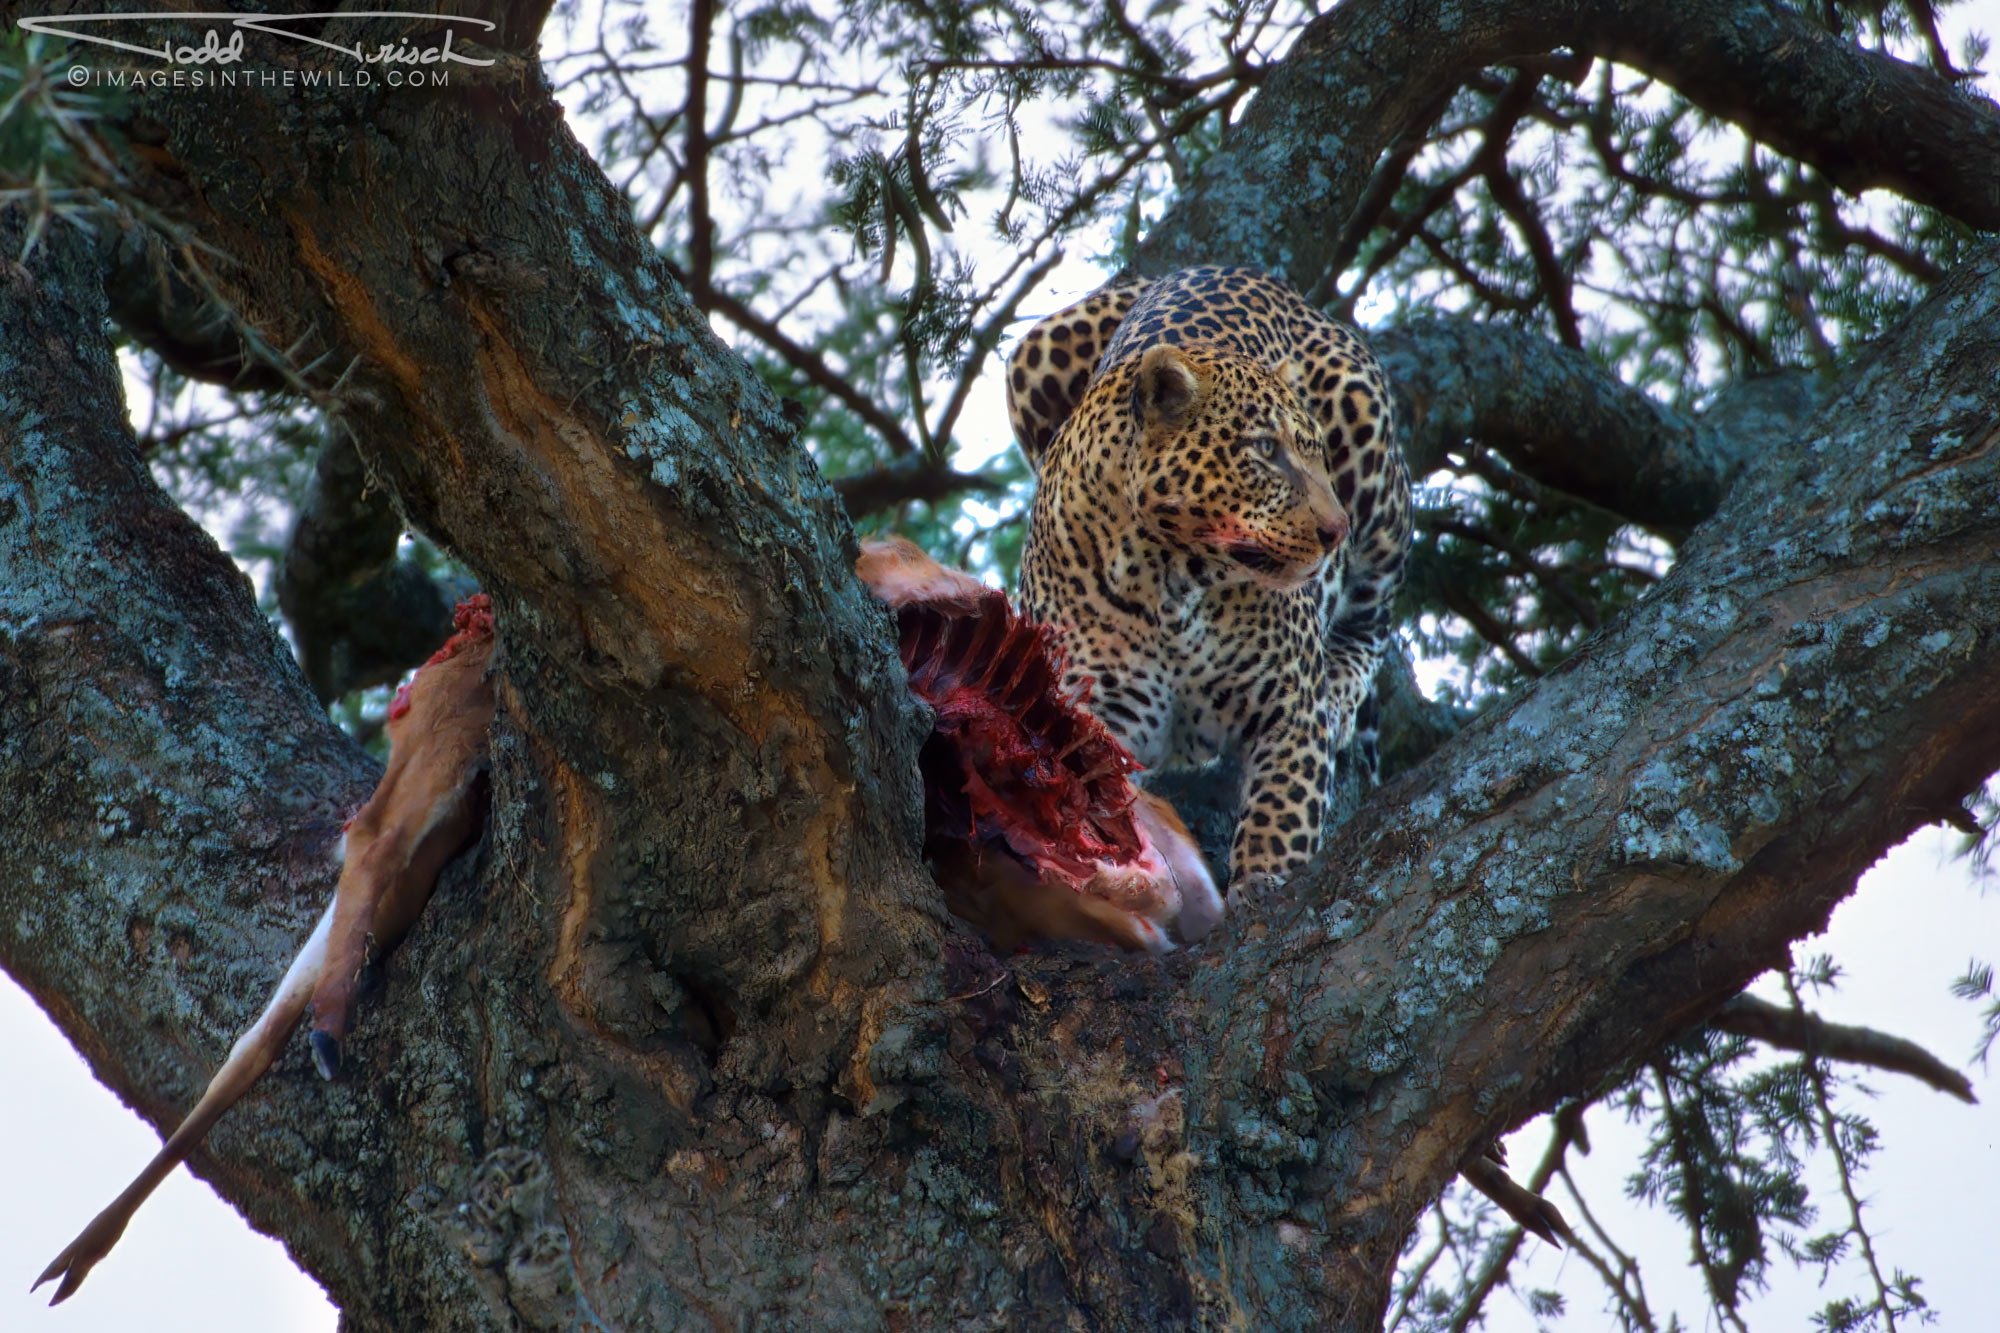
left=1124, top=344, right=1348, bottom=590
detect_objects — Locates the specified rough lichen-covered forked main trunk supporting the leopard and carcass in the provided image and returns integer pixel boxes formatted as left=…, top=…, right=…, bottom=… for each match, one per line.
left=0, top=6, right=2000, bottom=1329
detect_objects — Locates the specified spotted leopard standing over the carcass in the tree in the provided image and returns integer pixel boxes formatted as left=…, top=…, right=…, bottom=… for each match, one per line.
left=1006, top=266, right=1412, bottom=899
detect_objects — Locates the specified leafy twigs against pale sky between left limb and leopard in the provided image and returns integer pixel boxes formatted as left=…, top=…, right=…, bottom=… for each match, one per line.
left=552, top=0, right=1310, bottom=574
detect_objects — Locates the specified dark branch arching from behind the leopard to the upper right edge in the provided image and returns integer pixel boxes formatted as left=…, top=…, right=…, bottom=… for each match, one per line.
left=1136, top=0, right=2000, bottom=288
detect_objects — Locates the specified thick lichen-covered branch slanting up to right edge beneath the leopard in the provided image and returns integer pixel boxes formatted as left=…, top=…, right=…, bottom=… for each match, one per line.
left=1194, top=246, right=2000, bottom=1304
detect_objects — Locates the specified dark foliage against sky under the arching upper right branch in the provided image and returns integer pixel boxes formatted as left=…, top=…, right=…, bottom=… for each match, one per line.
left=1344, top=62, right=1970, bottom=406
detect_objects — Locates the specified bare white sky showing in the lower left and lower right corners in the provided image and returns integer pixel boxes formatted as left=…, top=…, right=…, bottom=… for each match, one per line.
left=0, top=0, right=2000, bottom=1333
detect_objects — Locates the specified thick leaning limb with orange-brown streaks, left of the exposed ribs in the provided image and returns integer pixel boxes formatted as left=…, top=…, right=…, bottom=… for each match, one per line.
left=78, top=2, right=936, bottom=1069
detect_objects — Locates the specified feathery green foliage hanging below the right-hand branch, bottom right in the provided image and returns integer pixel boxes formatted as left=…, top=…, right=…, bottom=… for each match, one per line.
left=1388, top=944, right=1952, bottom=1333
